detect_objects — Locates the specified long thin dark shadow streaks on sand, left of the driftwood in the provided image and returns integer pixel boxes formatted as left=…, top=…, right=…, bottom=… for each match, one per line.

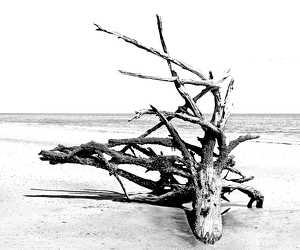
left=24, top=188, right=125, bottom=201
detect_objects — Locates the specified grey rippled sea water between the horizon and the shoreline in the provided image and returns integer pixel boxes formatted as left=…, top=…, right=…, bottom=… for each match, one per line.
left=0, top=114, right=300, bottom=145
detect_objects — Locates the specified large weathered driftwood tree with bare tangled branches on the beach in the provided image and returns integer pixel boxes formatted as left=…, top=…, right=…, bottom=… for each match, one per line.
left=40, top=16, right=264, bottom=244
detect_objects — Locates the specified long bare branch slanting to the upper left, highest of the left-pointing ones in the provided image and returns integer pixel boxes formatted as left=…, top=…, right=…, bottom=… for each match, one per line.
left=94, top=23, right=206, bottom=80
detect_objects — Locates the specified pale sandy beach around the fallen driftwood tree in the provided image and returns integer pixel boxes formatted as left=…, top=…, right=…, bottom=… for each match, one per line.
left=0, top=128, right=300, bottom=249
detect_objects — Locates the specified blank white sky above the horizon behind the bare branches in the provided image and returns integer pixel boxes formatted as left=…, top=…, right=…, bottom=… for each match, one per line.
left=0, top=0, right=300, bottom=113
